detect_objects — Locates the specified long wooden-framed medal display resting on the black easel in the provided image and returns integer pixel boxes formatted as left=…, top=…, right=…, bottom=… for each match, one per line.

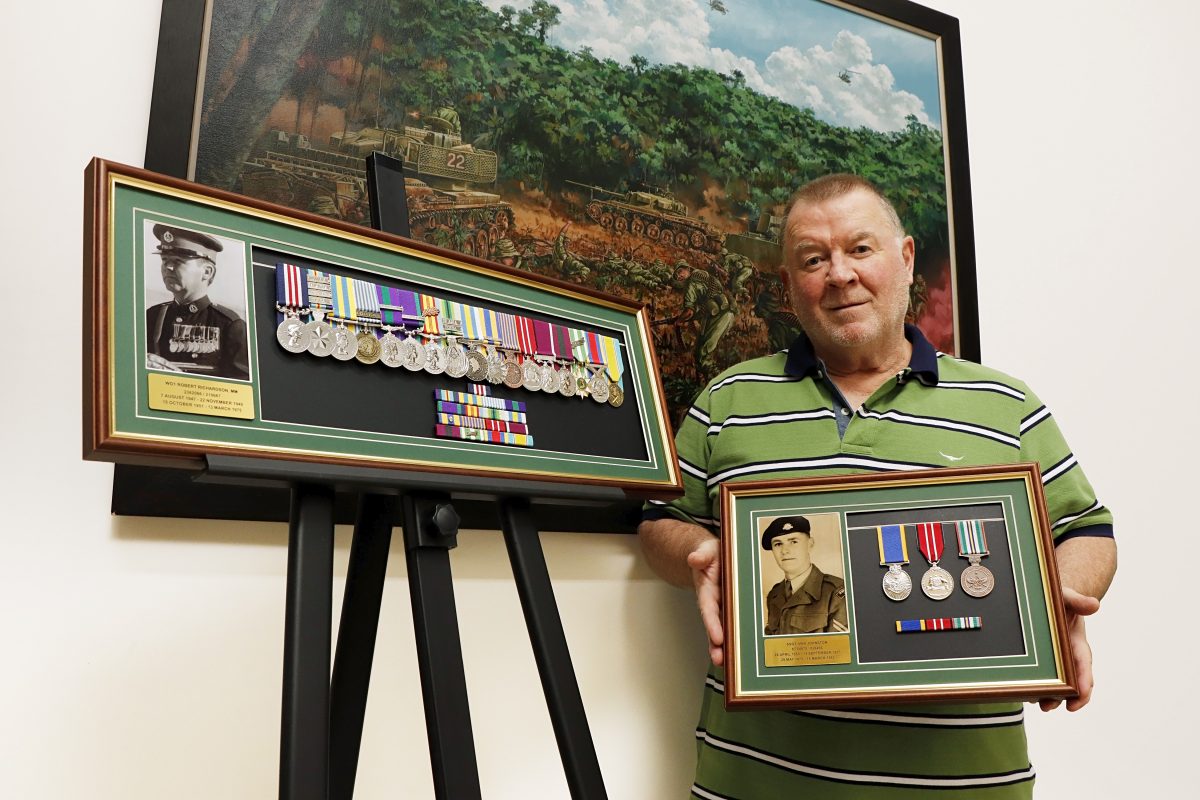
left=84, top=160, right=680, bottom=497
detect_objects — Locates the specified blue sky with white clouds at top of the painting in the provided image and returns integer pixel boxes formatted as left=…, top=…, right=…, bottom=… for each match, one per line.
left=482, top=0, right=942, bottom=131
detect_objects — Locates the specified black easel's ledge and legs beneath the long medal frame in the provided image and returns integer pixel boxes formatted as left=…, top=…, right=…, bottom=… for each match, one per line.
left=197, top=456, right=624, bottom=800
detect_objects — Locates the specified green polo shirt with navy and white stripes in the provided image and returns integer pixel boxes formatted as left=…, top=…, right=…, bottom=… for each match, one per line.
left=643, top=326, right=1112, bottom=800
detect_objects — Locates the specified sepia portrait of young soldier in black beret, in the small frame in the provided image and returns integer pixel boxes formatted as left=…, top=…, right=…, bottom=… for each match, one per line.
left=762, top=517, right=847, bottom=636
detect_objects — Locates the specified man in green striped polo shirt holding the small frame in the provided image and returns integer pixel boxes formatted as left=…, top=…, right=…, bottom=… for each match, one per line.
left=638, top=175, right=1116, bottom=800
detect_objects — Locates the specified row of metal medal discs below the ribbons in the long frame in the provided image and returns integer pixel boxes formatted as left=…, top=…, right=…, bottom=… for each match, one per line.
left=275, top=306, right=625, bottom=408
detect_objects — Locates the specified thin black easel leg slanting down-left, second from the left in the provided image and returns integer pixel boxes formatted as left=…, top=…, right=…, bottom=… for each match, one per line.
left=329, top=494, right=396, bottom=800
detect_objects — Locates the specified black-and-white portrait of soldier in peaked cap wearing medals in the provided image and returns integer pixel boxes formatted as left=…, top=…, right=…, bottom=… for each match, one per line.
left=146, top=224, right=250, bottom=380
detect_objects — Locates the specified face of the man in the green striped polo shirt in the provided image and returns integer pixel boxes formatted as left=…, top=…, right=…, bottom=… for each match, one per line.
left=780, top=190, right=913, bottom=354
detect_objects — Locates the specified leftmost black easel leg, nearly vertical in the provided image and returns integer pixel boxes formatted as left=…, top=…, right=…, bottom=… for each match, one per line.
left=280, top=483, right=334, bottom=800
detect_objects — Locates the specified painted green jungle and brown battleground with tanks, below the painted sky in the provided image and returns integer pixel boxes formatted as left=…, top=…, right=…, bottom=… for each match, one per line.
left=194, top=0, right=955, bottom=419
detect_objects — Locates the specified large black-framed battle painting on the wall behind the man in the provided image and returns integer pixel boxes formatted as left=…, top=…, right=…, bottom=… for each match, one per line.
left=146, top=0, right=979, bottom=431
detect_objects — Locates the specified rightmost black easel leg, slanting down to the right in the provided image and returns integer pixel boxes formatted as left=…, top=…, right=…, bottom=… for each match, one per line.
left=502, top=498, right=608, bottom=800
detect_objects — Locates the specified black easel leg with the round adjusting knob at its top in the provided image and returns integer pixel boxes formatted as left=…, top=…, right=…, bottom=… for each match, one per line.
left=401, top=495, right=480, bottom=800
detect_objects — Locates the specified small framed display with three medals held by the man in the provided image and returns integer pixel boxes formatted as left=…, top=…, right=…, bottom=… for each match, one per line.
left=721, top=464, right=1076, bottom=710
